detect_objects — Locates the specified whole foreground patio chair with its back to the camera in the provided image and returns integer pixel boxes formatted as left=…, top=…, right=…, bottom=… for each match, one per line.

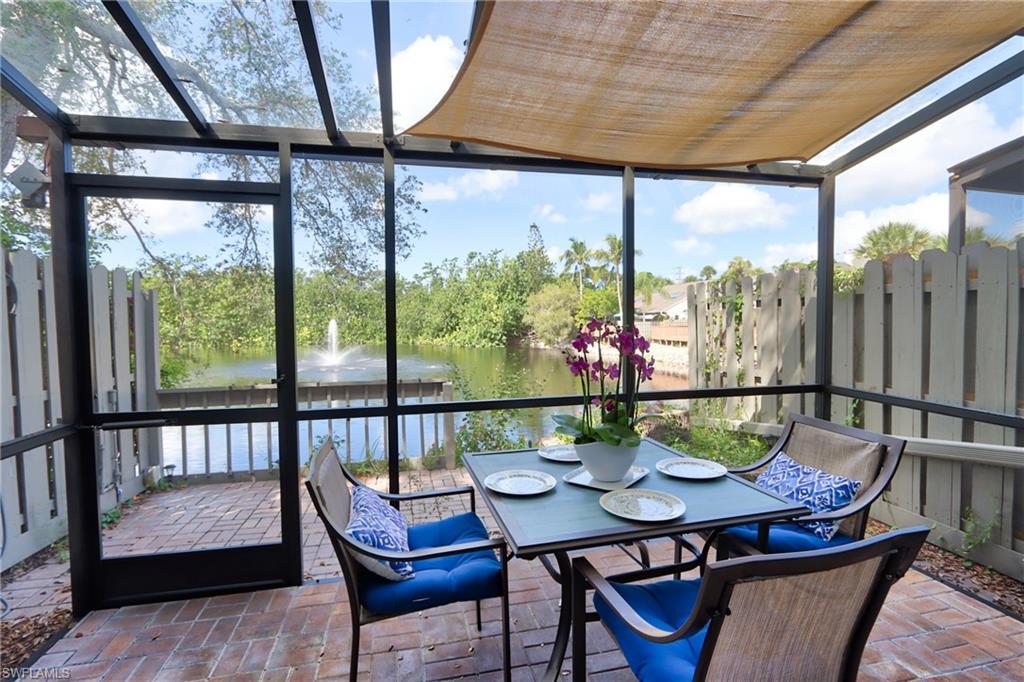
left=572, top=526, right=928, bottom=682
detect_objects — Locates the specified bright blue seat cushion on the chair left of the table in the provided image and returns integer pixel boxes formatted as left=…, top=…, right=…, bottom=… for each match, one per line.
left=359, top=514, right=502, bottom=614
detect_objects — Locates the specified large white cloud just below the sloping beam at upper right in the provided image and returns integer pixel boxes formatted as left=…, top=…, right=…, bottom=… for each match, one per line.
left=836, top=101, right=1024, bottom=206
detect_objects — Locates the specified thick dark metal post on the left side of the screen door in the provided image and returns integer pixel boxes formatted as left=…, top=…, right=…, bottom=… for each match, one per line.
left=49, top=134, right=101, bottom=616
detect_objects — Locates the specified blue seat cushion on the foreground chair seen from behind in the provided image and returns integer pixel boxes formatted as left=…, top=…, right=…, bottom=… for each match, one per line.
left=594, top=580, right=708, bottom=682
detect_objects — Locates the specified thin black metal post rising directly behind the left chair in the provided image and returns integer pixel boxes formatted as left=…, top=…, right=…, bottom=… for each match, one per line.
left=385, top=146, right=400, bottom=493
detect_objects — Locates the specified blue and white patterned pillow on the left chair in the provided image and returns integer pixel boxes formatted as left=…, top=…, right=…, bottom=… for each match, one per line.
left=345, top=485, right=413, bottom=581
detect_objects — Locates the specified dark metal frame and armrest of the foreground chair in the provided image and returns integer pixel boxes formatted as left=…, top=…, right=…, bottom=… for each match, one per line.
left=572, top=526, right=928, bottom=682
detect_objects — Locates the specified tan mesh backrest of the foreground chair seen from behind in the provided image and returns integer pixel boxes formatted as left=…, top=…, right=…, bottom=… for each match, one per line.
left=694, top=527, right=928, bottom=682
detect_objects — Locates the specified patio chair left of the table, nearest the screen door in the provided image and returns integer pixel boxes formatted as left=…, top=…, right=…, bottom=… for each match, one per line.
left=306, top=440, right=511, bottom=682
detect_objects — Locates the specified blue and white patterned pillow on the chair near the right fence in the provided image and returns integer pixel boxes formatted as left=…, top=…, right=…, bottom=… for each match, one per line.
left=756, top=453, right=862, bottom=542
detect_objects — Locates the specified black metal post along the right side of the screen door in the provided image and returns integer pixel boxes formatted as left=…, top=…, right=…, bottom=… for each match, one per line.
left=274, top=143, right=302, bottom=585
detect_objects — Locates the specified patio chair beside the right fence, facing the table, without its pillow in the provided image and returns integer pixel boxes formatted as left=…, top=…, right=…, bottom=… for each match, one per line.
left=674, top=414, right=906, bottom=563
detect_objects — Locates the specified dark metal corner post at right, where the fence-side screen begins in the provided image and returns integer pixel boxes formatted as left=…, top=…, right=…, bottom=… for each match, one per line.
left=814, top=175, right=836, bottom=419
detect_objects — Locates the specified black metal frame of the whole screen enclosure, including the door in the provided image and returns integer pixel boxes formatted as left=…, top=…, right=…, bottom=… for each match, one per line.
left=0, top=0, right=1024, bottom=614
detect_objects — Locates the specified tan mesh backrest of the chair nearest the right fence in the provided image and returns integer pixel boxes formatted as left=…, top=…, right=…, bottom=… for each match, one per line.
left=774, top=414, right=906, bottom=539
